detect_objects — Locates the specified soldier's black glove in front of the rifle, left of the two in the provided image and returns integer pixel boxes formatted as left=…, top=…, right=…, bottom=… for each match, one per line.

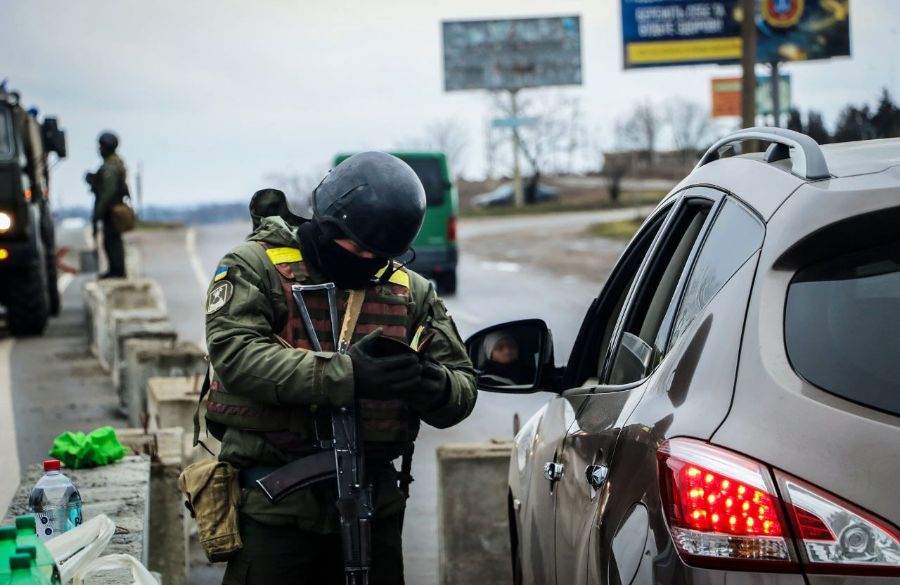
left=347, top=328, right=422, bottom=400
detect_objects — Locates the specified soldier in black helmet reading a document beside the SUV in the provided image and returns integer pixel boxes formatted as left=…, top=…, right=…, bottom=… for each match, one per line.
left=206, top=152, right=476, bottom=585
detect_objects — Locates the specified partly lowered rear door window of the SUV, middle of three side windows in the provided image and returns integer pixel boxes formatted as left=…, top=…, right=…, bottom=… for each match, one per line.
left=608, top=199, right=713, bottom=385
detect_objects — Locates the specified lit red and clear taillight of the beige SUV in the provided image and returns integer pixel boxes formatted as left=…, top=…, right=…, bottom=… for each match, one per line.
left=658, top=438, right=900, bottom=576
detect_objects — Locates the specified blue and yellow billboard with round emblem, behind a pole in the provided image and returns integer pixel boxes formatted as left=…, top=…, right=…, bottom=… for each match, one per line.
left=621, top=0, right=850, bottom=69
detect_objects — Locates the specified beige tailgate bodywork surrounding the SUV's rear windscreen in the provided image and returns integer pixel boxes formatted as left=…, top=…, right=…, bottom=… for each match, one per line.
left=713, top=167, right=900, bottom=526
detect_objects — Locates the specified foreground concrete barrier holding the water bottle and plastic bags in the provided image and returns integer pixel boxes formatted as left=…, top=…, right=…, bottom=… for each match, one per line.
left=3, top=455, right=150, bottom=585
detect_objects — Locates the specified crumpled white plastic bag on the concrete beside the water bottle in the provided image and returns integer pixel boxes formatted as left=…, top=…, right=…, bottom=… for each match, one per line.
left=46, top=514, right=159, bottom=585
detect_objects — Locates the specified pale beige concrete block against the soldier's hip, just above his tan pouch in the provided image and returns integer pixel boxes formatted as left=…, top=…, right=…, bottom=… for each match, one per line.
left=147, top=376, right=219, bottom=465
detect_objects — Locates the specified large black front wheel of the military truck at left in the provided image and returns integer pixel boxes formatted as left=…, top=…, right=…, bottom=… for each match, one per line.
left=6, top=259, right=50, bottom=337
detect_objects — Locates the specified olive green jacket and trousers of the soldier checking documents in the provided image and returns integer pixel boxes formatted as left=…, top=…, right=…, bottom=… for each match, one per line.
left=206, top=217, right=476, bottom=583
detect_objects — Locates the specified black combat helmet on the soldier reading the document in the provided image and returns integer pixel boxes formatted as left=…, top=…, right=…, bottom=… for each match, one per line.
left=312, top=152, right=425, bottom=258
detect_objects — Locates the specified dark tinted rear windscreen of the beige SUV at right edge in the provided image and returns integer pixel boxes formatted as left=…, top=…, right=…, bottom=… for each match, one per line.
left=785, top=242, right=900, bottom=415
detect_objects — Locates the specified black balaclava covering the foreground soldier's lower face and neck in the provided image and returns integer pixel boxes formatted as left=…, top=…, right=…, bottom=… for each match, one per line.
left=298, top=219, right=388, bottom=290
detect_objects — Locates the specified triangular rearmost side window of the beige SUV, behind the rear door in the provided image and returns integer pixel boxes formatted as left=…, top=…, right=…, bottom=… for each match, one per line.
left=669, top=198, right=765, bottom=347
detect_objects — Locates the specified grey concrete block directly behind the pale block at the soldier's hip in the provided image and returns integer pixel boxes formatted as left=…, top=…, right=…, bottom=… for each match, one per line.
left=120, top=339, right=207, bottom=427
